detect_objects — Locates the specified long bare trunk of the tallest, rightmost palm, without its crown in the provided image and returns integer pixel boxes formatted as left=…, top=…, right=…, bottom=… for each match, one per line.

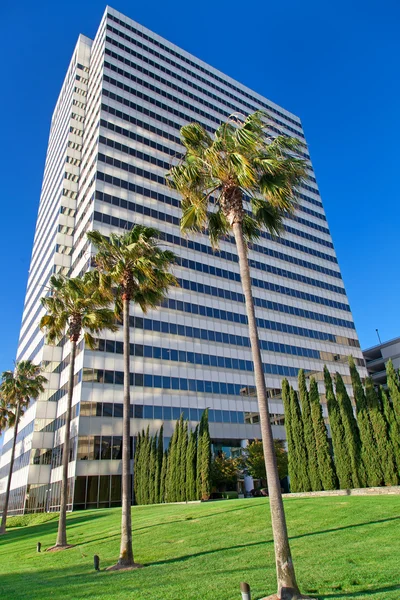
left=232, top=222, right=300, bottom=600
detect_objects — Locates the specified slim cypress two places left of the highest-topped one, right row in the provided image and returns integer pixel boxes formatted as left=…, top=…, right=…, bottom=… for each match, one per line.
left=324, top=365, right=353, bottom=490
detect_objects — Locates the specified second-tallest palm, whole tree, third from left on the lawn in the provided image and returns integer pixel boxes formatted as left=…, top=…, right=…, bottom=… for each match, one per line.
left=88, top=225, right=177, bottom=569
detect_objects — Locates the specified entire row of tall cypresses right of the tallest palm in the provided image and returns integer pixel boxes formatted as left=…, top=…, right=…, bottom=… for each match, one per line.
left=282, top=357, right=400, bottom=492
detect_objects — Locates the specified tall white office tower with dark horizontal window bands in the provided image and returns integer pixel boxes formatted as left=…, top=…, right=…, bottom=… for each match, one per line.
left=0, top=8, right=365, bottom=513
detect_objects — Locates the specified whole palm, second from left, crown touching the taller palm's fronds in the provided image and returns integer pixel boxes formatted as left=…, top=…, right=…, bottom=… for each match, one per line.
left=40, top=271, right=118, bottom=549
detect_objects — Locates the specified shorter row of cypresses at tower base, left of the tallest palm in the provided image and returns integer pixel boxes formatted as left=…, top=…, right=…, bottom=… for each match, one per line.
left=134, top=409, right=211, bottom=504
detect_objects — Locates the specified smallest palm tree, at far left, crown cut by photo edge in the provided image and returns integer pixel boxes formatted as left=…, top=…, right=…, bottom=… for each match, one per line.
left=0, top=360, right=47, bottom=534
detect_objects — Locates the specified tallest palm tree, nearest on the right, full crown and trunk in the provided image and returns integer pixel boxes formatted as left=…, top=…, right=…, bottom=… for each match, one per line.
left=167, top=111, right=306, bottom=598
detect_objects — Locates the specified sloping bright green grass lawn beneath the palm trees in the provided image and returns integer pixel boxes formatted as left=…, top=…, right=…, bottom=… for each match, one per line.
left=0, top=496, right=400, bottom=600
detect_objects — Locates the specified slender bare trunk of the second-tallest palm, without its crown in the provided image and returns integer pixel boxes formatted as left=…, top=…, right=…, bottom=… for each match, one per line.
left=118, top=297, right=134, bottom=567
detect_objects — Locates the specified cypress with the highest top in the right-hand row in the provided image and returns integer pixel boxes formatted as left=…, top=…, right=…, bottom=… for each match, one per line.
left=349, top=356, right=383, bottom=487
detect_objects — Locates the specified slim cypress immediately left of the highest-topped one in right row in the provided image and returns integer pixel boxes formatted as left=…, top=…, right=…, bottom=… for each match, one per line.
left=335, top=373, right=365, bottom=488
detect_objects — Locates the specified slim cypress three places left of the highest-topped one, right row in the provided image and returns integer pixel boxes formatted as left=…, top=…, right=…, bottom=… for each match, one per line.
left=309, top=377, right=337, bottom=490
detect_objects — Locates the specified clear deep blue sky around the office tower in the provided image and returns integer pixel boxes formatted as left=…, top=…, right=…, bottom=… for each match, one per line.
left=0, top=0, right=400, bottom=371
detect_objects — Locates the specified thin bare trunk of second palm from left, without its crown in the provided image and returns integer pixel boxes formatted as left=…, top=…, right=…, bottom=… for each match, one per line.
left=56, top=340, right=76, bottom=547
